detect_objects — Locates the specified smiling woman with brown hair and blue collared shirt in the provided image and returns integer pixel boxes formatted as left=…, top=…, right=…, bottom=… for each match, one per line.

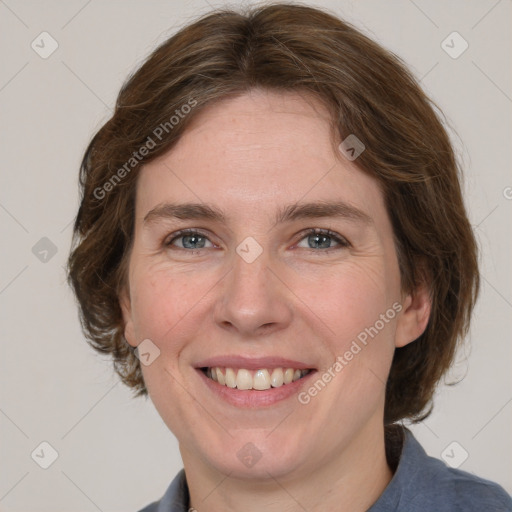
left=69, top=4, right=512, bottom=512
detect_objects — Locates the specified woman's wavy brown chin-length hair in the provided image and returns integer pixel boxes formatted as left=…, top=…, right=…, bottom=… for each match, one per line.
left=68, top=4, right=479, bottom=423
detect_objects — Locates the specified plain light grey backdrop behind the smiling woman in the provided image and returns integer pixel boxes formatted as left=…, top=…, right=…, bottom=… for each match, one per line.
left=0, top=0, right=512, bottom=512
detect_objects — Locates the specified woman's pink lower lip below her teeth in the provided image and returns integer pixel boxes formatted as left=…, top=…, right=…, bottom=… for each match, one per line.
left=196, top=369, right=316, bottom=409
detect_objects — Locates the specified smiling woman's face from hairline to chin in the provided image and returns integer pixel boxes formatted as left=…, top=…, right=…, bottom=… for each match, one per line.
left=122, top=91, right=428, bottom=478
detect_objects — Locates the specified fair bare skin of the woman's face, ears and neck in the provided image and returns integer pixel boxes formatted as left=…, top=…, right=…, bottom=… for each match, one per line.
left=121, top=91, right=429, bottom=512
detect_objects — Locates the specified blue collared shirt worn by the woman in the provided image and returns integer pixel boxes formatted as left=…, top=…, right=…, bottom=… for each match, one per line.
left=140, top=428, right=512, bottom=512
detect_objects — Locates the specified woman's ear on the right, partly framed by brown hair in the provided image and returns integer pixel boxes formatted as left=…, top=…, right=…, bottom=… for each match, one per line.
left=395, top=283, right=432, bottom=347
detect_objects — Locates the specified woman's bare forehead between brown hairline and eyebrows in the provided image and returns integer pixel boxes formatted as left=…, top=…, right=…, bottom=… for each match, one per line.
left=137, top=91, right=383, bottom=224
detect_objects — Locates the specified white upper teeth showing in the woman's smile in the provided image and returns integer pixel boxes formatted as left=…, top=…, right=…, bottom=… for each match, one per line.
left=201, top=366, right=314, bottom=391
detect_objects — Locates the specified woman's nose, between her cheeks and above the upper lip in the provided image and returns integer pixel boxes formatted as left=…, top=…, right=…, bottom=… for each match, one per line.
left=215, top=251, right=292, bottom=339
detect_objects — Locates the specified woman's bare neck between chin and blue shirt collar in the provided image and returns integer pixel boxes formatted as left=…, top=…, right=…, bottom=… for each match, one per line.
left=180, top=420, right=393, bottom=512
